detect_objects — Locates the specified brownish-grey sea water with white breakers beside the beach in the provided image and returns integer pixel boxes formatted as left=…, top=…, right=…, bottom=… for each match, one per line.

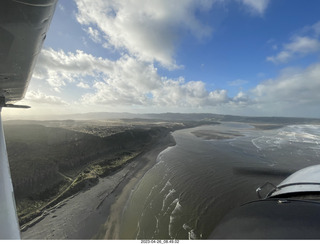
left=120, top=122, right=320, bottom=239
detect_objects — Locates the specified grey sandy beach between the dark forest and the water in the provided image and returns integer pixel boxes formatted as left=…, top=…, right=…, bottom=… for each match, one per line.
left=21, top=134, right=174, bottom=240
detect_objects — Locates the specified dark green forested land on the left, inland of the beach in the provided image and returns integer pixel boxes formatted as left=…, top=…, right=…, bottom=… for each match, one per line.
left=4, top=121, right=201, bottom=228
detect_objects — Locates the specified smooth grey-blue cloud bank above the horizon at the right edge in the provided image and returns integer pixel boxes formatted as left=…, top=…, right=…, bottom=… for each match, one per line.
left=214, top=63, right=320, bottom=117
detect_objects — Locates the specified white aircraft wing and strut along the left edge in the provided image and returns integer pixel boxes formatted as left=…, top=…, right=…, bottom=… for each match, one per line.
left=0, top=0, right=57, bottom=239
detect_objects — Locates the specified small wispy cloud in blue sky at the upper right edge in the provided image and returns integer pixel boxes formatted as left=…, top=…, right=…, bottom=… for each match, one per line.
left=267, top=22, right=320, bottom=63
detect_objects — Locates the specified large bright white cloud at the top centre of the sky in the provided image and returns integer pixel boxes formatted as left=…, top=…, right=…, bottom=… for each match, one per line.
left=75, top=0, right=213, bottom=69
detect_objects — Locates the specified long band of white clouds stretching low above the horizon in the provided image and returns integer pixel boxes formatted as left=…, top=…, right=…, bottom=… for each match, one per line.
left=37, top=49, right=320, bottom=112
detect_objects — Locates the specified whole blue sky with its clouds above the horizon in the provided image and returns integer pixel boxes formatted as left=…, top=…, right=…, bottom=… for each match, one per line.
left=4, top=0, right=320, bottom=118
